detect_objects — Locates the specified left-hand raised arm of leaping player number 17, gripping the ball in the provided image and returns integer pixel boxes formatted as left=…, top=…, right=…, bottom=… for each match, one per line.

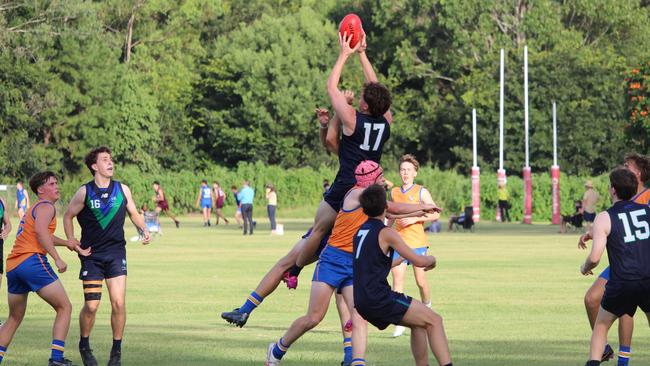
left=327, top=33, right=361, bottom=135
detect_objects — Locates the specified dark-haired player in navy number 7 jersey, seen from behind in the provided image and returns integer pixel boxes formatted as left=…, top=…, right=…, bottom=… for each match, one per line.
left=353, top=185, right=451, bottom=366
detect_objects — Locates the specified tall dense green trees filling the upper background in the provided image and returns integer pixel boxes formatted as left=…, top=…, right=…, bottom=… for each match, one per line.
left=0, top=0, right=650, bottom=178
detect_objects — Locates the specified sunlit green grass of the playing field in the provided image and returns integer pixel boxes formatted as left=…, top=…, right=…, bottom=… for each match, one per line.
left=0, top=217, right=650, bottom=366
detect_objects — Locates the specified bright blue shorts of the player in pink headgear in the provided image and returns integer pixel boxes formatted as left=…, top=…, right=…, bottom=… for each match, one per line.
left=312, top=245, right=352, bottom=291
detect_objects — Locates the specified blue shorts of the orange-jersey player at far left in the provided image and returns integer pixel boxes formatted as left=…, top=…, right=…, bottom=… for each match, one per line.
left=7, top=253, right=59, bottom=295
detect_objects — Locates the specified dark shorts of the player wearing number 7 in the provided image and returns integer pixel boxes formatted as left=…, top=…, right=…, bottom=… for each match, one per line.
left=355, top=291, right=413, bottom=330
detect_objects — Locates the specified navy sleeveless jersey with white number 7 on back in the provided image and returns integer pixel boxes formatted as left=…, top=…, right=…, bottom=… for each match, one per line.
left=352, top=218, right=393, bottom=307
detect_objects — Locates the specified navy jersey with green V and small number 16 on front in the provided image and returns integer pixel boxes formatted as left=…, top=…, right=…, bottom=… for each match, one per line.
left=77, top=180, right=127, bottom=257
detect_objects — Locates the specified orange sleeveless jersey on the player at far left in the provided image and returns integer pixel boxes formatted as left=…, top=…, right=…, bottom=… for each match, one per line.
left=7, top=201, right=56, bottom=272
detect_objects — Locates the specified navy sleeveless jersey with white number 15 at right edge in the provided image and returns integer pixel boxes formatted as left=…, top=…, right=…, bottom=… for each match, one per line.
left=607, top=201, right=650, bottom=281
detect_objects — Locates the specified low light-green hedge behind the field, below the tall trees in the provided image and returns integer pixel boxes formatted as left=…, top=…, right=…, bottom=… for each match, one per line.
left=49, top=162, right=610, bottom=221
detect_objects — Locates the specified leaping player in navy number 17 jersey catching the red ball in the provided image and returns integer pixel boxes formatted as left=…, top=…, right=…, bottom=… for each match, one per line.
left=290, top=34, right=393, bottom=284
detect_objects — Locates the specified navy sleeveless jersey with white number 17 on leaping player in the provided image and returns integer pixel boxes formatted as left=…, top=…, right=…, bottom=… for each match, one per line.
left=336, top=112, right=390, bottom=184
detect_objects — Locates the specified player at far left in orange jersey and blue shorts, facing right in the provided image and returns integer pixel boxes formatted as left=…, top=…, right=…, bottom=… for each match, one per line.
left=0, top=172, right=90, bottom=366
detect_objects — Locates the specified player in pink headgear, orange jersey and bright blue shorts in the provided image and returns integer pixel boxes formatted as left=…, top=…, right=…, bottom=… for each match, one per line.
left=265, top=161, right=436, bottom=366
